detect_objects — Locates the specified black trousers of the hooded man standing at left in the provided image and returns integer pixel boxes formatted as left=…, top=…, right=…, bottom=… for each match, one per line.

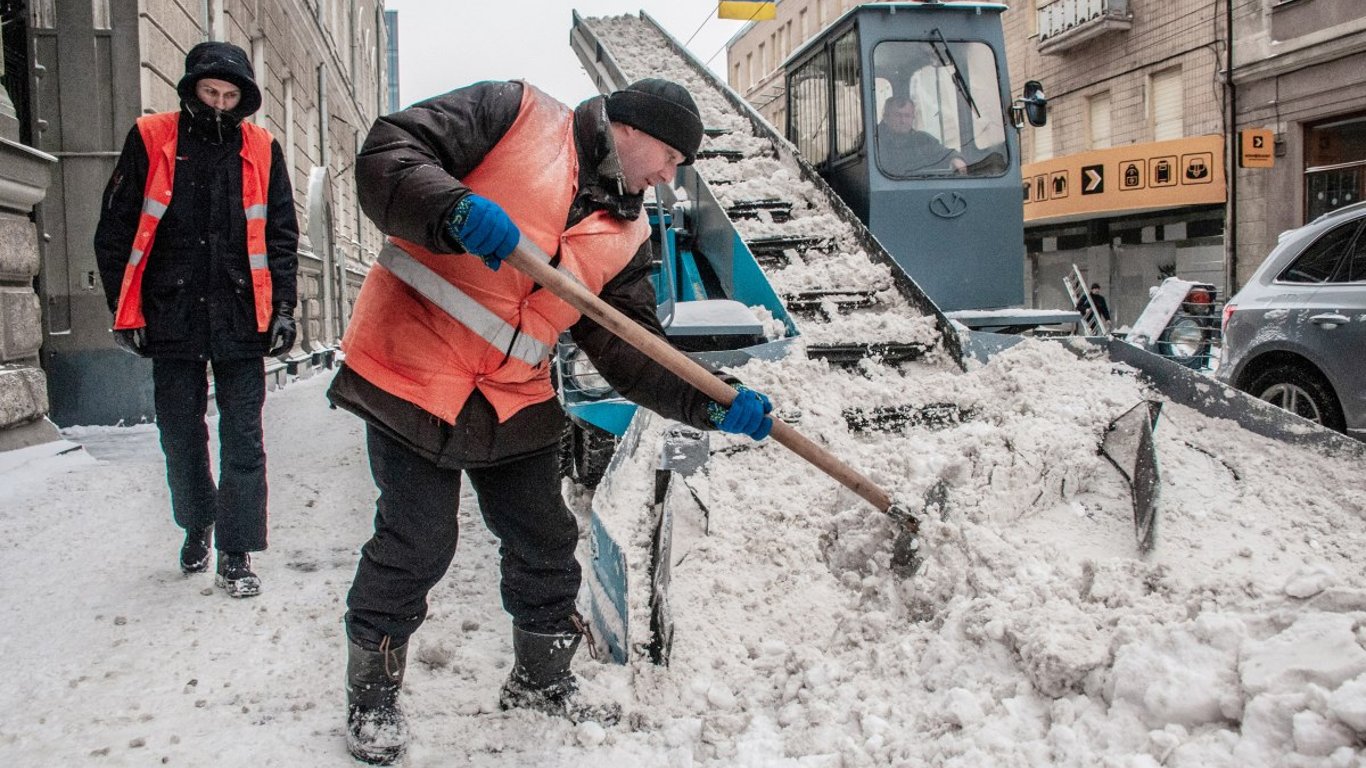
left=152, top=358, right=266, bottom=552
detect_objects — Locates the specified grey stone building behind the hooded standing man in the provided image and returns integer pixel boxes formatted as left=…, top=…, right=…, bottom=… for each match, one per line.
left=7, top=0, right=388, bottom=426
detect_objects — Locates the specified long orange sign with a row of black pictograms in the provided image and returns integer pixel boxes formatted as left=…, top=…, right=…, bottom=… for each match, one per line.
left=1022, top=135, right=1225, bottom=224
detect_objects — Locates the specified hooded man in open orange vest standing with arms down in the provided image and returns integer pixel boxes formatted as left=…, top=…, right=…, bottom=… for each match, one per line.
left=94, top=42, right=299, bottom=597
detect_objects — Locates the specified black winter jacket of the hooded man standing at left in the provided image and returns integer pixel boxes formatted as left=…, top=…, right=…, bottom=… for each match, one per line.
left=94, top=109, right=299, bottom=359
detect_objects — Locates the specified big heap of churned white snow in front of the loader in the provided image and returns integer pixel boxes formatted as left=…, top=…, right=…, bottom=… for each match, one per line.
left=598, top=340, right=1366, bottom=767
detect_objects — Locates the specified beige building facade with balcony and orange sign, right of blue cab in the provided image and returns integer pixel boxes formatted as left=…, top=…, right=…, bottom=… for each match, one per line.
left=1004, top=0, right=1229, bottom=328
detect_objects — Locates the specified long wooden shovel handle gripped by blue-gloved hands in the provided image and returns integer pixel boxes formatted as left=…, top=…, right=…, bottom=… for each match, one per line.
left=503, top=238, right=892, bottom=512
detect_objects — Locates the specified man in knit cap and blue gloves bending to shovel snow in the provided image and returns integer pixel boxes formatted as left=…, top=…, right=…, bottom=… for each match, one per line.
left=329, top=78, right=773, bottom=764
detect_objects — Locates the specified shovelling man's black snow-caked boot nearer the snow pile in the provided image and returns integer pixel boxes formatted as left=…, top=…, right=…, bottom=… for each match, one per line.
left=499, top=627, right=622, bottom=726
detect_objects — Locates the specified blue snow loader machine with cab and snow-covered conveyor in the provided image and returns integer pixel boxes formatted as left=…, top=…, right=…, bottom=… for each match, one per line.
left=553, top=3, right=1355, bottom=663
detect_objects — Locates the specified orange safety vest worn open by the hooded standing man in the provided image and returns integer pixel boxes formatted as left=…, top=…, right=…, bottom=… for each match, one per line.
left=113, top=112, right=272, bottom=332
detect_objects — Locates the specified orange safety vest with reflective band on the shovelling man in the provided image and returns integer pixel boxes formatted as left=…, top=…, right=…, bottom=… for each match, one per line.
left=342, top=83, right=649, bottom=424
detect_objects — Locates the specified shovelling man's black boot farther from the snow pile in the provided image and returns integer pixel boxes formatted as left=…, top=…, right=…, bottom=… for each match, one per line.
left=346, top=637, right=408, bottom=765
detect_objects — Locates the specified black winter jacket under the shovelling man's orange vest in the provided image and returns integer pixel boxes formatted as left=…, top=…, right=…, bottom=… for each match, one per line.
left=328, top=82, right=714, bottom=469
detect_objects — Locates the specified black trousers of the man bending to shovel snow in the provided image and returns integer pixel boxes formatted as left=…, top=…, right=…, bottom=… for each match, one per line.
left=346, top=426, right=581, bottom=648
